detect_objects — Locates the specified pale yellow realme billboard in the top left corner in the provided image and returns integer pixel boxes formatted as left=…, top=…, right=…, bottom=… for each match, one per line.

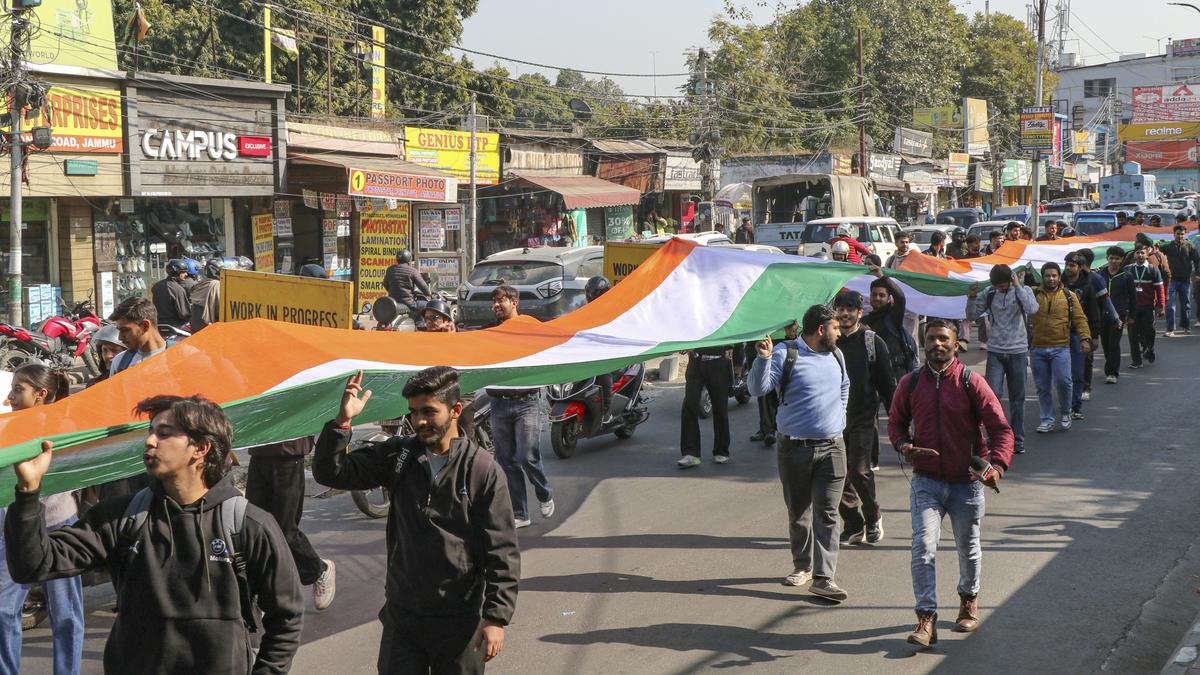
left=29, top=0, right=118, bottom=71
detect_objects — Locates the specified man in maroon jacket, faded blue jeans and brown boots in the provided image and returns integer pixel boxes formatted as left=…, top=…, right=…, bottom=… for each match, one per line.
left=888, top=318, right=1013, bottom=646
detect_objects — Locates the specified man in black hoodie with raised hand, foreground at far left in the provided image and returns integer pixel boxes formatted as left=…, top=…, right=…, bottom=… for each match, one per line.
left=5, top=395, right=304, bottom=675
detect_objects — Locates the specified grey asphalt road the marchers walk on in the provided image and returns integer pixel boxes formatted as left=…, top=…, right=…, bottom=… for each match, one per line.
left=22, top=336, right=1200, bottom=675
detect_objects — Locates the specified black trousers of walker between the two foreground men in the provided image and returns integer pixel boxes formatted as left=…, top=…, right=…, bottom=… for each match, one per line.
left=246, top=456, right=325, bottom=586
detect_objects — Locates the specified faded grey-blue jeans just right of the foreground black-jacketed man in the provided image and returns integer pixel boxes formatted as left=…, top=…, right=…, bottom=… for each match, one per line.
left=492, top=394, right=554, bottom=520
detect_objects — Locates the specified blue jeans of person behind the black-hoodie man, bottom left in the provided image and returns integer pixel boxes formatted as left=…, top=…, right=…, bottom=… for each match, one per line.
left=0, top=509, right=83, bottom=675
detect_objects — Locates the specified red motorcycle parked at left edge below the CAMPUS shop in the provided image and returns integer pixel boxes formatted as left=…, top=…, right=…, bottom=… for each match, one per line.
left=0, top=297, right=101, bottom=377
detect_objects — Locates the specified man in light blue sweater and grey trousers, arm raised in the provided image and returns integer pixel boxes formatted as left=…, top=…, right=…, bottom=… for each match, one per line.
left=746, top=305, right=850, bottom=603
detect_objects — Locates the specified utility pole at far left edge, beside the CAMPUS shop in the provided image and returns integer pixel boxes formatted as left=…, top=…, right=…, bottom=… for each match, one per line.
left=8, top=5, right=29, bottom=325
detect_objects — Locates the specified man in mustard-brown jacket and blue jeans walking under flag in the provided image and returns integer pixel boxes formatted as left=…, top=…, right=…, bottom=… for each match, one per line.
left=1030, top=263, right=1092, bottom=434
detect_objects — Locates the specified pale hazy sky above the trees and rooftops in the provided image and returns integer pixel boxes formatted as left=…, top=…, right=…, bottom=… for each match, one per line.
left=462, top=0, right=1200, bottom=95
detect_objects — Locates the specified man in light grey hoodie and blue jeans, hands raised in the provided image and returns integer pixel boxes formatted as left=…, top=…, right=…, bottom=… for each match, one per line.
left=967, top=264, right=1038, bottom=453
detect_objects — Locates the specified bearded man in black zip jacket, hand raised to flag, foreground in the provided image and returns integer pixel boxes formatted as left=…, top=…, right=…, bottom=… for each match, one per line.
left=312, top=366, right=521, bottom=674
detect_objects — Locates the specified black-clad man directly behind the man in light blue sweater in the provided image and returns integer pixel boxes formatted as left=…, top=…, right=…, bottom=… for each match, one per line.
left=833, top=291, right=896, bottom=544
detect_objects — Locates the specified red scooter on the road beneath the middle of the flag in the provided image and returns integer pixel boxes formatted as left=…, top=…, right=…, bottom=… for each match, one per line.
left=547, top=363, right=650, bottom=459
